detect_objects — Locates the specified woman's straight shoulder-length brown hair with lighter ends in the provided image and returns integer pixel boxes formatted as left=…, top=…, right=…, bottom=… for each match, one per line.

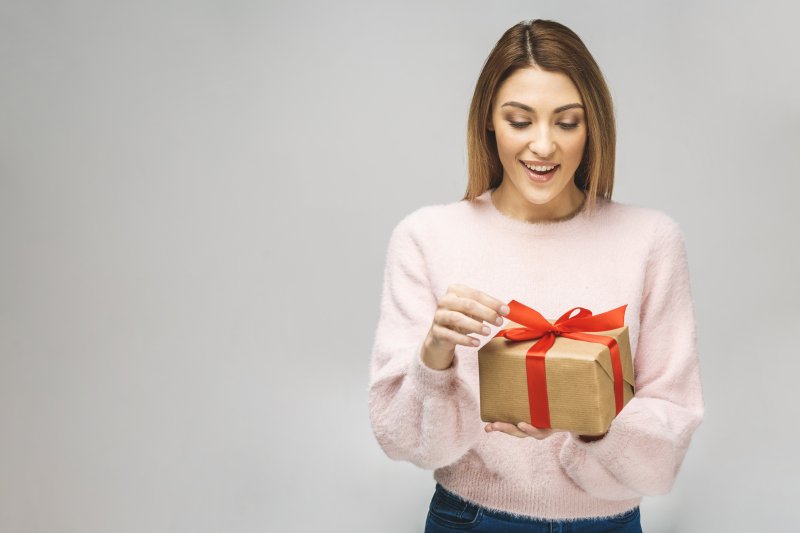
left=463, top=19, right=616, bottom=209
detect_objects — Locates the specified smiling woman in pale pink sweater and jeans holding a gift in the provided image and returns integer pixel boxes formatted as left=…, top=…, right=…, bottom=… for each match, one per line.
left=369, top=20, right=703, bottom=532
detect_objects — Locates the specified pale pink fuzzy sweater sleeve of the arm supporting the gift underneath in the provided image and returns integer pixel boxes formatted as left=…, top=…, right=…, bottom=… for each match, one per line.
left=560, top=216, right=704, bottom=500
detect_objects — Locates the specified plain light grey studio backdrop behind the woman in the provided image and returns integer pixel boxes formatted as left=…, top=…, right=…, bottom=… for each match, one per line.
left=0, top=0, right=800, bottom=533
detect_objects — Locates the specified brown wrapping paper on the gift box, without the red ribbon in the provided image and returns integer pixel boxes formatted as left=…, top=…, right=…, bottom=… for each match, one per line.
left=478, top=320, right=634, bottom=435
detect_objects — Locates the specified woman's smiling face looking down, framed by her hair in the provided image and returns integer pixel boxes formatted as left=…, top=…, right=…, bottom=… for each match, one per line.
left=487, top=67, right=587, bottom=214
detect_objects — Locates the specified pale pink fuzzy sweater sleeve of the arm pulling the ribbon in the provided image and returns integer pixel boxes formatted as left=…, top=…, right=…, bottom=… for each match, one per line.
left=368, top=217, right=481, bottom=469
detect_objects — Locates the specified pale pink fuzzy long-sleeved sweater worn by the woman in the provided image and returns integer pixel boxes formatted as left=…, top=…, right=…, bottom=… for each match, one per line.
left=368, top=190, right=703, bottom=519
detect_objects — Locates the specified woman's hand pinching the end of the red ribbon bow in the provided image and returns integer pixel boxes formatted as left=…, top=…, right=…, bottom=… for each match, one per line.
left=421, top=284, right=510, bottom=370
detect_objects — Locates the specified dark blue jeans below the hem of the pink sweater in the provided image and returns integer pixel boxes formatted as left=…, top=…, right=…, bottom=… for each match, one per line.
left=425, top=483, right=642, bottom=533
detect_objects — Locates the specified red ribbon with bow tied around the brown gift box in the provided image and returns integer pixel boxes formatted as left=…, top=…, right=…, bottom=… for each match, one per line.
left=495, top=300, right=628, bottom=429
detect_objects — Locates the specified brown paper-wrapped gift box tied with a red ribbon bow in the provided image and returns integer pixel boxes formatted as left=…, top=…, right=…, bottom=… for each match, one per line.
left=478, top=300, right=635, bottom=435
